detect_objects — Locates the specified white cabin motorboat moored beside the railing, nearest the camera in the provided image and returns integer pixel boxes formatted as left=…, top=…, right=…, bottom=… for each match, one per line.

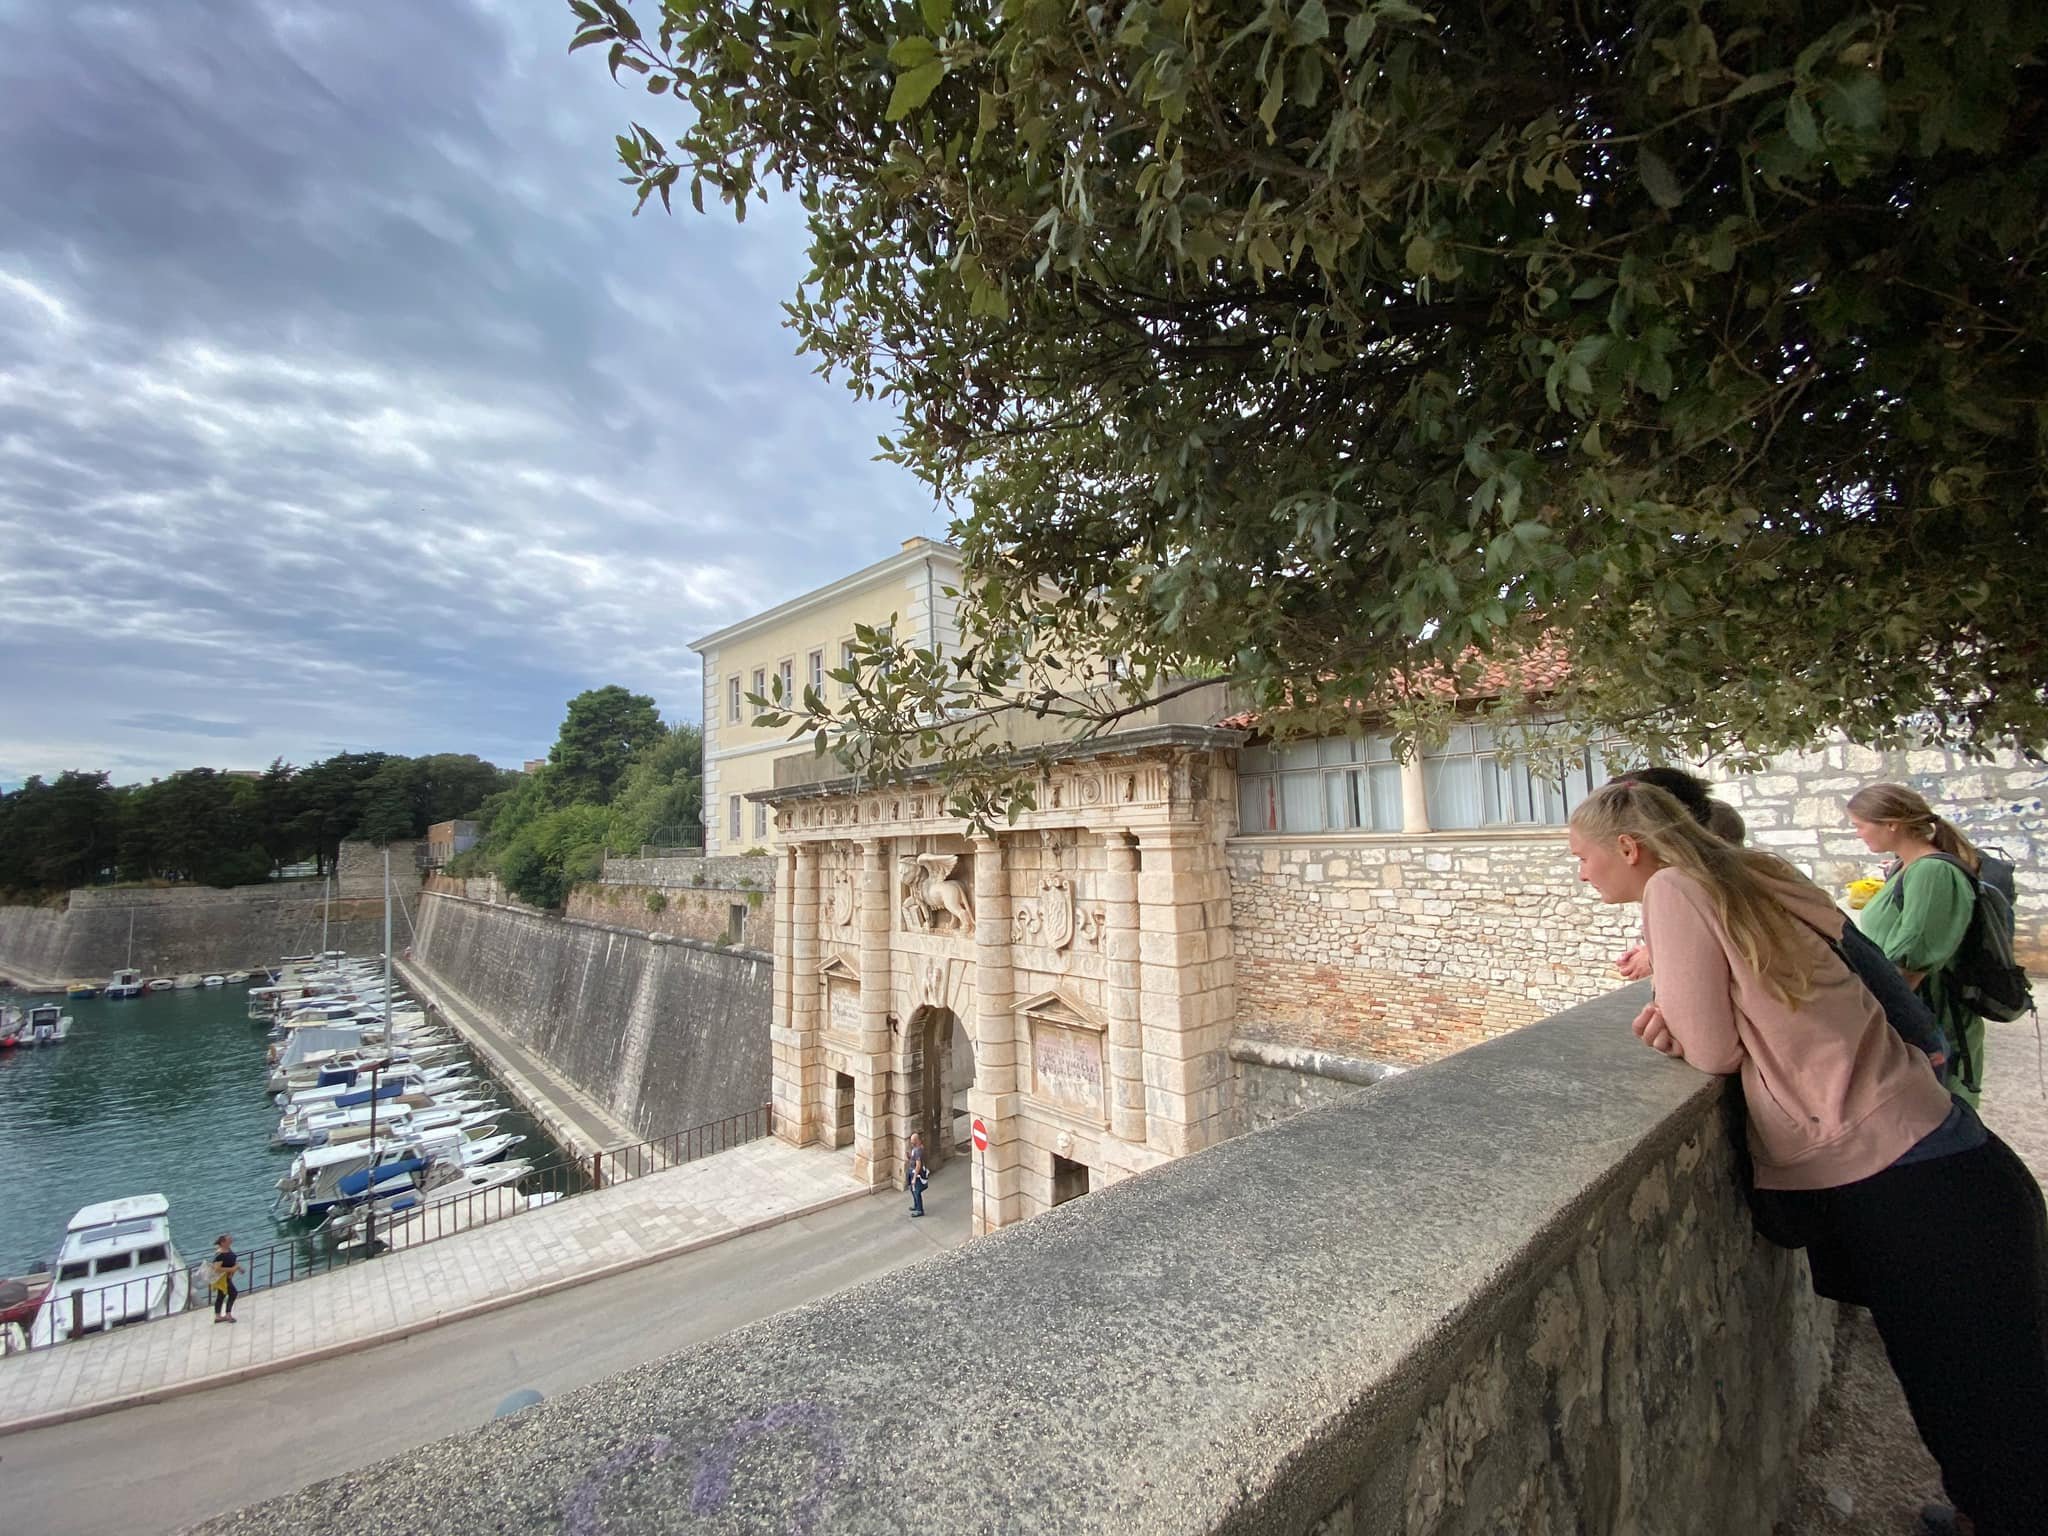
left=29, top=1194, right=193, bottom=1346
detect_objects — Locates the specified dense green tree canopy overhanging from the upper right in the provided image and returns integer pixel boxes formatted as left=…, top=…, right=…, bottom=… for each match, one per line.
left=571, top=0, right=2048, bottom=819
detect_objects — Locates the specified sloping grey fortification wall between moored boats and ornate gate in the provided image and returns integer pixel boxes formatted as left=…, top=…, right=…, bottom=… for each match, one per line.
left=412, top=893, right=770, bottom=1137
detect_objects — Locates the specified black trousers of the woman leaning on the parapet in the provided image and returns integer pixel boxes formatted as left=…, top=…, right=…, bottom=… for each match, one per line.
left=1755, top=1137, right=2048, bottom=1536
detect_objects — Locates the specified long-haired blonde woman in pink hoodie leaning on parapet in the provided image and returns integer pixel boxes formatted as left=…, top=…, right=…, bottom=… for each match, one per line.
left=1569, top=782, right=2048, bottom=1536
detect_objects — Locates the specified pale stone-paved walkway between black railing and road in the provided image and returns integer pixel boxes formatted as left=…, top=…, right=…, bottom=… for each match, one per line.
left=0, top=1137, right=870, bottom=1436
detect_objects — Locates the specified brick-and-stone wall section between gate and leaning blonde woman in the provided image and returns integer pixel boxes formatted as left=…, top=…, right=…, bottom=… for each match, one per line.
left=1229, top=829, right=1640, bottom=1065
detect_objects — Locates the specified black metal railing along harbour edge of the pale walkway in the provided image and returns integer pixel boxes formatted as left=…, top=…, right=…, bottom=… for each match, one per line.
left=10, top=1104, right=774, bottom=1350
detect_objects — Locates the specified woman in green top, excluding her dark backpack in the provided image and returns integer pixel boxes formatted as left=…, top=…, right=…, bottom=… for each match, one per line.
left=1849, top=784, right=1985, bottom=1108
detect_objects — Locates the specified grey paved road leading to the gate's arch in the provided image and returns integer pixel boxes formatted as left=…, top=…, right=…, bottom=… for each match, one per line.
left=0, top=1161, right=969, bottom=1536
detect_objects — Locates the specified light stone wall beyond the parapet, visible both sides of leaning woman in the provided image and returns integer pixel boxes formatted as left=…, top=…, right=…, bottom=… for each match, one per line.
left=1229, top=743, right=2048, bottom=1063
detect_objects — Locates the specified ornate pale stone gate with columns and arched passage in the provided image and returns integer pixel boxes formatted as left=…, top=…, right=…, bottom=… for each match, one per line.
left=756, top=725, right=1243, bottom=1231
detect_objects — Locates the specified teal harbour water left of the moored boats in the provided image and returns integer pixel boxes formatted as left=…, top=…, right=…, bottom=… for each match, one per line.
left=0, top=987, right=557, bottom=1284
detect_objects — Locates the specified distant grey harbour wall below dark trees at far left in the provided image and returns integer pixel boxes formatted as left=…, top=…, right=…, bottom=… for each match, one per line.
left=0, top=881, right=387, bottom=987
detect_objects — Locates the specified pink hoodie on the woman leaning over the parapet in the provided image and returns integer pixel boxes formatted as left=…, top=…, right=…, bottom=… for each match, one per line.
left=1642, top=868, right=1950, bottom=1190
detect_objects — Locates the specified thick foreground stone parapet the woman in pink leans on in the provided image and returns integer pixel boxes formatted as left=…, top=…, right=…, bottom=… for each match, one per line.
left=188, top=989, right=1833, bottom=1536
